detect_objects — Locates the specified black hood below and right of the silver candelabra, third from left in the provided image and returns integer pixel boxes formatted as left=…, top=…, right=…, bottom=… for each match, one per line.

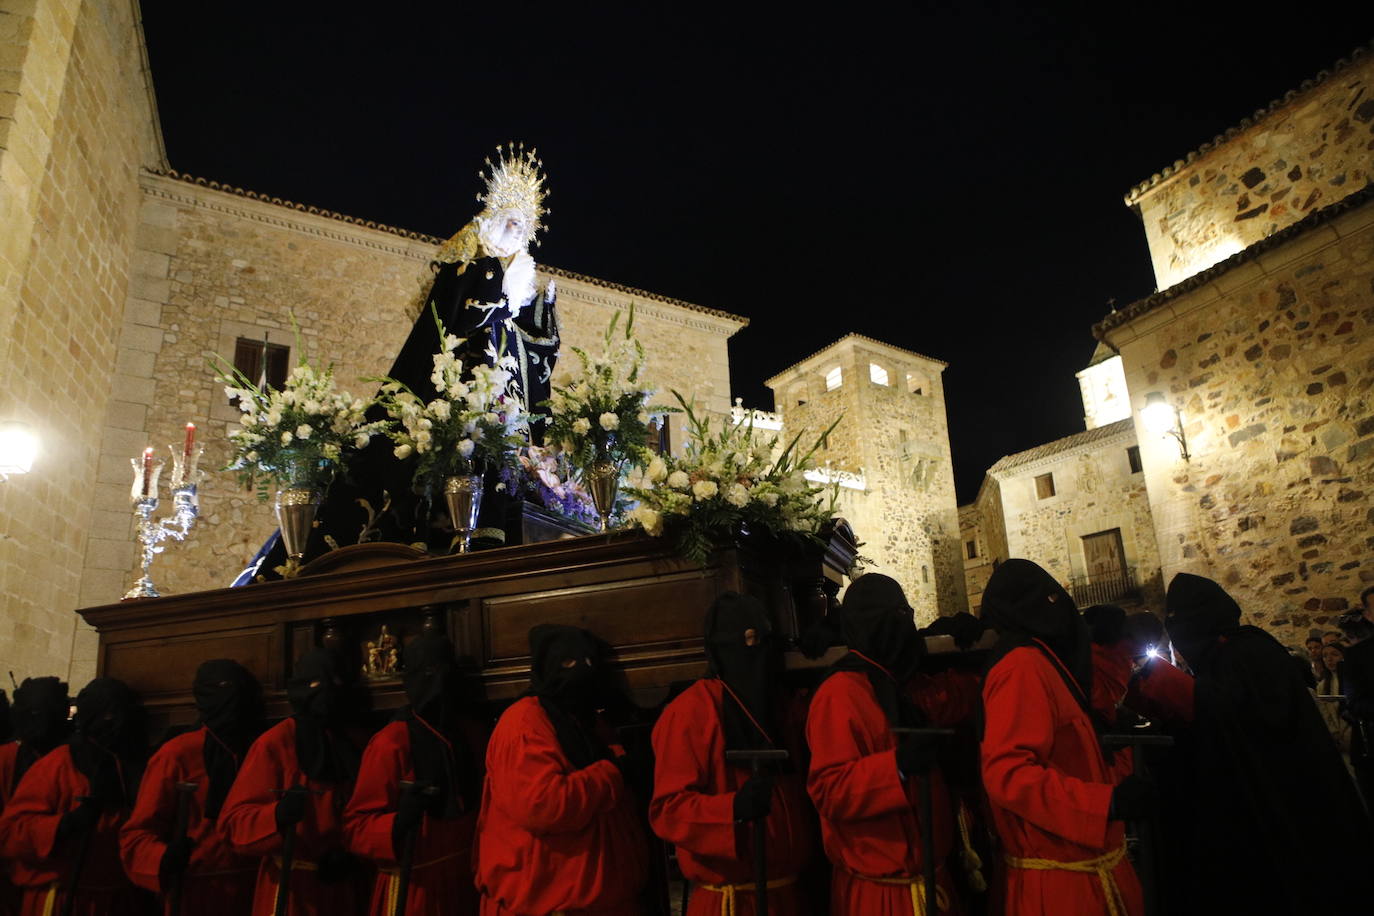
left=191, top=658, right=262, bottom=820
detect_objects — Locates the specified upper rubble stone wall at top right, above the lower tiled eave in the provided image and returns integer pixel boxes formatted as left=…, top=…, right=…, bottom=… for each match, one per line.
left=1127, top=54, right=1374, bottom=290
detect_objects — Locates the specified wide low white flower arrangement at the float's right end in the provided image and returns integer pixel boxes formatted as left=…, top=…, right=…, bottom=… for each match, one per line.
left=627, top=391, right=840, bottom=564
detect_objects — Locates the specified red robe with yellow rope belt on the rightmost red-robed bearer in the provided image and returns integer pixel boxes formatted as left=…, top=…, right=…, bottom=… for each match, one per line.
left=982, top=647, right=1143, bottom=916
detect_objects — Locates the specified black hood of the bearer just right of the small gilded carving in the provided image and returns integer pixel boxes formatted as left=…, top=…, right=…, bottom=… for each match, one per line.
left=396, top=633, right=481, bottom=817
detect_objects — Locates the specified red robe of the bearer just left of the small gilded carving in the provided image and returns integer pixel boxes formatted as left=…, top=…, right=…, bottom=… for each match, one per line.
left=220, top=718, right=371, bottom=916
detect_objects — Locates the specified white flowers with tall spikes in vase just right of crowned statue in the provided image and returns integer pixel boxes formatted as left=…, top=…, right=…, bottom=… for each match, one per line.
left=543, top=304, right=675, bottom=470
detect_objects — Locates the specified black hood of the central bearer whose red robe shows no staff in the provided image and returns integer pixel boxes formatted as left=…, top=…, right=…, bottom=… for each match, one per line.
left=529, top=623, right=613, bottom=769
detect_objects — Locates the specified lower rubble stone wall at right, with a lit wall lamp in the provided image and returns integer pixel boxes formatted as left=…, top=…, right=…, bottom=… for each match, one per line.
left=1098, top=197, right=1374, bottom=643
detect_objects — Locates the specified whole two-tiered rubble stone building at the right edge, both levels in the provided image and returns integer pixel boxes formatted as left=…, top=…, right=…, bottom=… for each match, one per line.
left=1094, top=44, right=1374, bottom=643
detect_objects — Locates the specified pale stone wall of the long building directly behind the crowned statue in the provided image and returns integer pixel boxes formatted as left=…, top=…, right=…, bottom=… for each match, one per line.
left=88, top=174, right=742, bottom=603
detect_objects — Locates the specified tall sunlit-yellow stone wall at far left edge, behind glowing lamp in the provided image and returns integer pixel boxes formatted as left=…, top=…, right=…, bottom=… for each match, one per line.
left=0, top=0, right=162, bottom=687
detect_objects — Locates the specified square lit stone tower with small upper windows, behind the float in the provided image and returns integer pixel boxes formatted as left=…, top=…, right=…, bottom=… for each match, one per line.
left=767, top=334, right=967, bottom=622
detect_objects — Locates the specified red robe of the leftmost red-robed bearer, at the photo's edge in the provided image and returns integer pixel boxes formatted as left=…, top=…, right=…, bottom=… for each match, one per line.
left=0, top=746, right=147, bottom=916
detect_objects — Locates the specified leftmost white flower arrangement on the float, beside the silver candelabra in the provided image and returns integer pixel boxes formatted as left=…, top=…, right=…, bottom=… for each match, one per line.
left=214, top=354, right=389, bottom=500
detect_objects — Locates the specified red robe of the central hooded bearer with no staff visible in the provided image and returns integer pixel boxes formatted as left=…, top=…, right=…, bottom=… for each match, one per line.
left=477, top=696, right=649, bottom=916
